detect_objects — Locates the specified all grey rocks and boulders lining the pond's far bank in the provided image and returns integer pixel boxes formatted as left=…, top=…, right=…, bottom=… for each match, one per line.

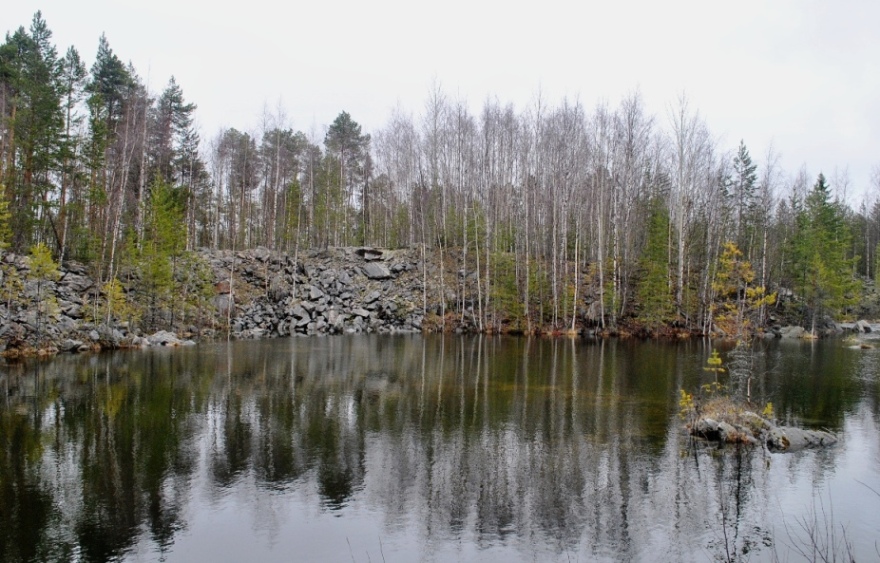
left=0, top=247, right=878, bottom=358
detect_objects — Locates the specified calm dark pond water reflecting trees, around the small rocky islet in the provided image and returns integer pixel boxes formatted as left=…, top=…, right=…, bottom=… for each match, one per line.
left=0, top=336, right=880, bottom=563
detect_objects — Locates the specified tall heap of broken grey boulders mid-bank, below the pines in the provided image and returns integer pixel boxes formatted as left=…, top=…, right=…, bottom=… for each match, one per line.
left=218, top=248, right=424, bottom=338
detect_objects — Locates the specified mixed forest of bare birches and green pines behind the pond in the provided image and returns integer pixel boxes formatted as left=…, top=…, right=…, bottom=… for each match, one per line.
left=0, top=12, right=880, bottom=334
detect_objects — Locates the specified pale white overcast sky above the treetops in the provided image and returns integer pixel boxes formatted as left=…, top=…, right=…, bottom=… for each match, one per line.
left=6, top=0, right=880, bottom=203
